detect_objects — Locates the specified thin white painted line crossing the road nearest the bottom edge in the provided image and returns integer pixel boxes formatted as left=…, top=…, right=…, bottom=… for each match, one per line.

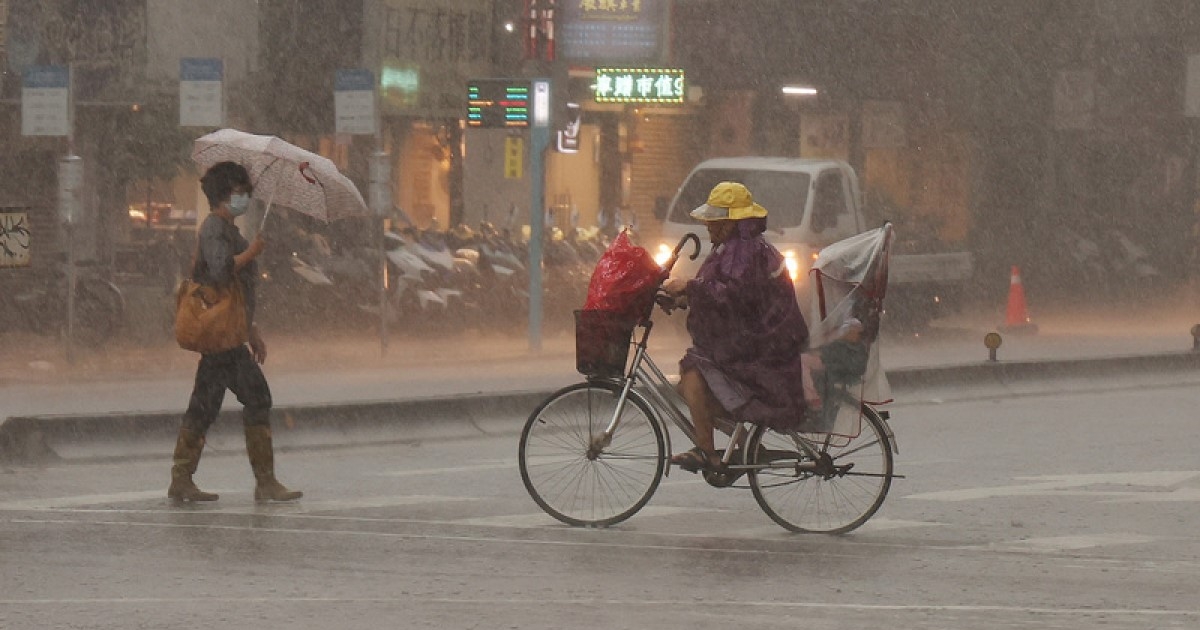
left=0, top=595, right=1200, bottom=619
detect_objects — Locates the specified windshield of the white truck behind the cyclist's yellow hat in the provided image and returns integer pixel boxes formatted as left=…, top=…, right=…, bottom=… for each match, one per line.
left=668, top=168, right=809, bottom=228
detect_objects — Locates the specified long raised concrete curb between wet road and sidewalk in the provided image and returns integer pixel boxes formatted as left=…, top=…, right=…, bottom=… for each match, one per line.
left=7, top=352, right=1200, bottom=464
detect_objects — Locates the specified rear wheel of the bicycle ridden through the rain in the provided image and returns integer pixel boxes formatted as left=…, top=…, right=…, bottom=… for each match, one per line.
left=746, top=406, right=893, bottom=534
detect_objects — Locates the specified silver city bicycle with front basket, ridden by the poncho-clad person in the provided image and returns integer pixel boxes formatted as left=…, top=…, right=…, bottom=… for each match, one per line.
left=517, top=226, right=896, bottom=534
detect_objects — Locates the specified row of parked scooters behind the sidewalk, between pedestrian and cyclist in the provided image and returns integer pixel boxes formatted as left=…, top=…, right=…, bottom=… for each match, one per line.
left=256, top=217, right=608, bottom=335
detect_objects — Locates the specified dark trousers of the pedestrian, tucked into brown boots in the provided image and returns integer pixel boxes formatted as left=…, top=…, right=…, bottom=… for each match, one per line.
left=184, top=346, right=271, bottom=436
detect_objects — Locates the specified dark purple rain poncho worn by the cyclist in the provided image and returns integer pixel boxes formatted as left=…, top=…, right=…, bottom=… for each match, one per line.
left=679, top=218, right=809, bottom=430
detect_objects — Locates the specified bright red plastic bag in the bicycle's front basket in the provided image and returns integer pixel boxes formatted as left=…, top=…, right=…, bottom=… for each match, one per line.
left=583, top=232, right=662, bottom=318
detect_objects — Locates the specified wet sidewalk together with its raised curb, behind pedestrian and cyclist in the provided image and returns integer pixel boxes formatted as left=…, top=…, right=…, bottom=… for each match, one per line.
left=0, top=300, right=1200, bottom=458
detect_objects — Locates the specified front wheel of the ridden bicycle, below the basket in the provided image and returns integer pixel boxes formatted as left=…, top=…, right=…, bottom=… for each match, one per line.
left=517, top=382, right=666, bottom=527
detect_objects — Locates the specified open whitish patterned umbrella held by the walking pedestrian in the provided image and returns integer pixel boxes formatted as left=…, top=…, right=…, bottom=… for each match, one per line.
left=192, top=130, right=368, bottom=222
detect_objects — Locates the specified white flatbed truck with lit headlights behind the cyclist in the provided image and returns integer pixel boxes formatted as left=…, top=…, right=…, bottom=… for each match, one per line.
left=646, top=157, right=973, bottom=326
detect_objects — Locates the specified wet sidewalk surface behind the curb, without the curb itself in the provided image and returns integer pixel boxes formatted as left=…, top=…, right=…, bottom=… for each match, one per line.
left=7, top=301, right=1200, bottom=419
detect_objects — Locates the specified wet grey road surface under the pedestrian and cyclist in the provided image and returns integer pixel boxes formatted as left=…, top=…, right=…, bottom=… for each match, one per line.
left=0, top=378, right=1200, bottom=629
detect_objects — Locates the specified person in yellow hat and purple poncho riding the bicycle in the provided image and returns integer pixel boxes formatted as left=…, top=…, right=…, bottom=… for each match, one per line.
left=662, top=181, right=809, bottom=472
